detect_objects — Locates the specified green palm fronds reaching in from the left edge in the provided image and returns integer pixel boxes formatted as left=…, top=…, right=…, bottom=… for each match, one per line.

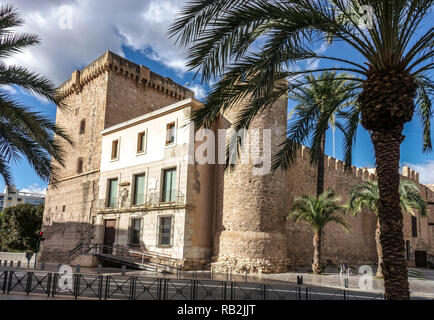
left=0, top=5, right=71, bottom=186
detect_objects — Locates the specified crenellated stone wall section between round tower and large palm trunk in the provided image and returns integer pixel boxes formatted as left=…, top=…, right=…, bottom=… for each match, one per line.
left=286, top=148, right=377, bottom=265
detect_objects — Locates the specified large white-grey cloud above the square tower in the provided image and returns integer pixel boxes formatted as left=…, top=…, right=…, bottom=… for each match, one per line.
left=0, top=0, right=187, bottom=84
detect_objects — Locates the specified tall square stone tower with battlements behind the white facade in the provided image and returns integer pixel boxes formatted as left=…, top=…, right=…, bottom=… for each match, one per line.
left=41, top=51, right=194, bottom=262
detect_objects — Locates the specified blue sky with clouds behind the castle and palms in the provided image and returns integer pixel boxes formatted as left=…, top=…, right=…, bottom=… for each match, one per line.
left=0, top=0, right=434, bottom=191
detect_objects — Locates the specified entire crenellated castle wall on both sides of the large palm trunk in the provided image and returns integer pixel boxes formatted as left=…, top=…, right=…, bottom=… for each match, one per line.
left=286, top=154, right=434, bottom=265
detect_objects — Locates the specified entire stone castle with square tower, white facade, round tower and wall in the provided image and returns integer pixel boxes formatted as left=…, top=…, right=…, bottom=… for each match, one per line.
left=42, top=52, right=434, bottom=273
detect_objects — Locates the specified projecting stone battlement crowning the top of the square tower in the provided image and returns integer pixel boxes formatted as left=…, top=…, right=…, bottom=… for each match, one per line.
left=58, top=51, right=194, bottom=100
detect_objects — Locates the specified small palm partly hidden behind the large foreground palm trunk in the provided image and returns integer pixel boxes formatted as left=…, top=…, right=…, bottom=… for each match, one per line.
left=348, top=180, right=427, bottom=277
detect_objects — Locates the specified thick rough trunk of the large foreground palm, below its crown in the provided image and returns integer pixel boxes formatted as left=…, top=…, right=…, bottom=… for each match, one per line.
left=371, top=126, right=410, bottom=300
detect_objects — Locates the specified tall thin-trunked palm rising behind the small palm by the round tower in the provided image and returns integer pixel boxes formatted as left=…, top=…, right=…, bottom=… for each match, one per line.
left=274, top=71, right=359, bottom=196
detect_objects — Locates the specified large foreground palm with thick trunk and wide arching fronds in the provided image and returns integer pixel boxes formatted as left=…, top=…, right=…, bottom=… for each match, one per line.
left=169, top=0, right=434, bottom=299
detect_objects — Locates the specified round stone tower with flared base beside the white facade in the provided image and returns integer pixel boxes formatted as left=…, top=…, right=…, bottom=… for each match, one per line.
left=213, top=97, right=287, bottom=273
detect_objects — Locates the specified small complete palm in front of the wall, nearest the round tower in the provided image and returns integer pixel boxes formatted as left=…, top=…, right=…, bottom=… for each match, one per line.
left=288, top=190, right=349, bottom=274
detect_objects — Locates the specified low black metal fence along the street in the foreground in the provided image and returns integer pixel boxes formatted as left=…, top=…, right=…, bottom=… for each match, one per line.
left=0, top=271, right=384, bottom=300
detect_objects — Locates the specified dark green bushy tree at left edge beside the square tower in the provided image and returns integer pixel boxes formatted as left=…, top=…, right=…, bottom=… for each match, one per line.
left=0, top=204, right=44, bottom=251
